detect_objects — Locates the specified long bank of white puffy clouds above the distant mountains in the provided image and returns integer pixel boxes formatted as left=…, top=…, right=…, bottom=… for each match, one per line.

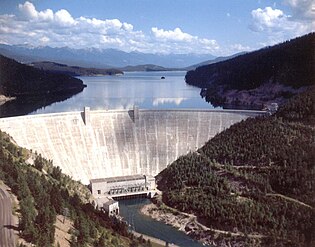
left=0, top=1, right=219, bottom=53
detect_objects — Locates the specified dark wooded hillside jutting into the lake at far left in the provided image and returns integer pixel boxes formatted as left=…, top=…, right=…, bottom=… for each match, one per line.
left=0, top=55, right=86, bottom=117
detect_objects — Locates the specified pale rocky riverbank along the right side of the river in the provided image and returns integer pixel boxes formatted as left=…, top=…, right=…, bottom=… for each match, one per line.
left=140, top=196, right=263, bottom=247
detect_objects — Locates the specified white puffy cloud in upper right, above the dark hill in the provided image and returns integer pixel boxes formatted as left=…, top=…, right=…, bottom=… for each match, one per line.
left=250, top=0, right=315, bottom=43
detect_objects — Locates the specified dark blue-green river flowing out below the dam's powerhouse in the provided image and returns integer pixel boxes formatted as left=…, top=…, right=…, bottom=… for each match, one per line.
left=119, top=198, right=203, bottom=247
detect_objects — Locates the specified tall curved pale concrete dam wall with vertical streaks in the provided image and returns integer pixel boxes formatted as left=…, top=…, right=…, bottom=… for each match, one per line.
left=0, top=107, right=264, bottom=184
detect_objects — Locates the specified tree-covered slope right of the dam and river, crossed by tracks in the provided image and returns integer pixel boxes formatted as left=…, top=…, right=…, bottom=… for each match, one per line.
left=158, top=87, right=315, bottom=247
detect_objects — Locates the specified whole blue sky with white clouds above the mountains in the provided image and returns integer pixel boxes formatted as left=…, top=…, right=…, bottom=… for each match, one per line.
left=0, top=0, right=315, bottom=56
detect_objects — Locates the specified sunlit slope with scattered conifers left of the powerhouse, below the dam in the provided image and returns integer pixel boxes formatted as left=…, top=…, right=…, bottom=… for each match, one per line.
left=0, top=131, right=151, bottom=247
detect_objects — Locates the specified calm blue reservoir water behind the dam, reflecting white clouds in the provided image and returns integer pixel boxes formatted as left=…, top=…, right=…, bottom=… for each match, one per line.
left=31, top=71, right=213, bottom=114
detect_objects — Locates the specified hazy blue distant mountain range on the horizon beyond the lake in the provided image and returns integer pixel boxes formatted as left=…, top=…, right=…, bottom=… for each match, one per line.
left=0, top=44, right=215, bottom=68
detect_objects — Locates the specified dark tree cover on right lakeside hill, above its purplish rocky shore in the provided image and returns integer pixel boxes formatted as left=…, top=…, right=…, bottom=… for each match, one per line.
left=185, top=33, right=315, bottom=89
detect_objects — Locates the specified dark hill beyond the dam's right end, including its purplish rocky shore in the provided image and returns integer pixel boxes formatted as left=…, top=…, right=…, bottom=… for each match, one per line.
left=185, top=33, right=315, bottom=106
